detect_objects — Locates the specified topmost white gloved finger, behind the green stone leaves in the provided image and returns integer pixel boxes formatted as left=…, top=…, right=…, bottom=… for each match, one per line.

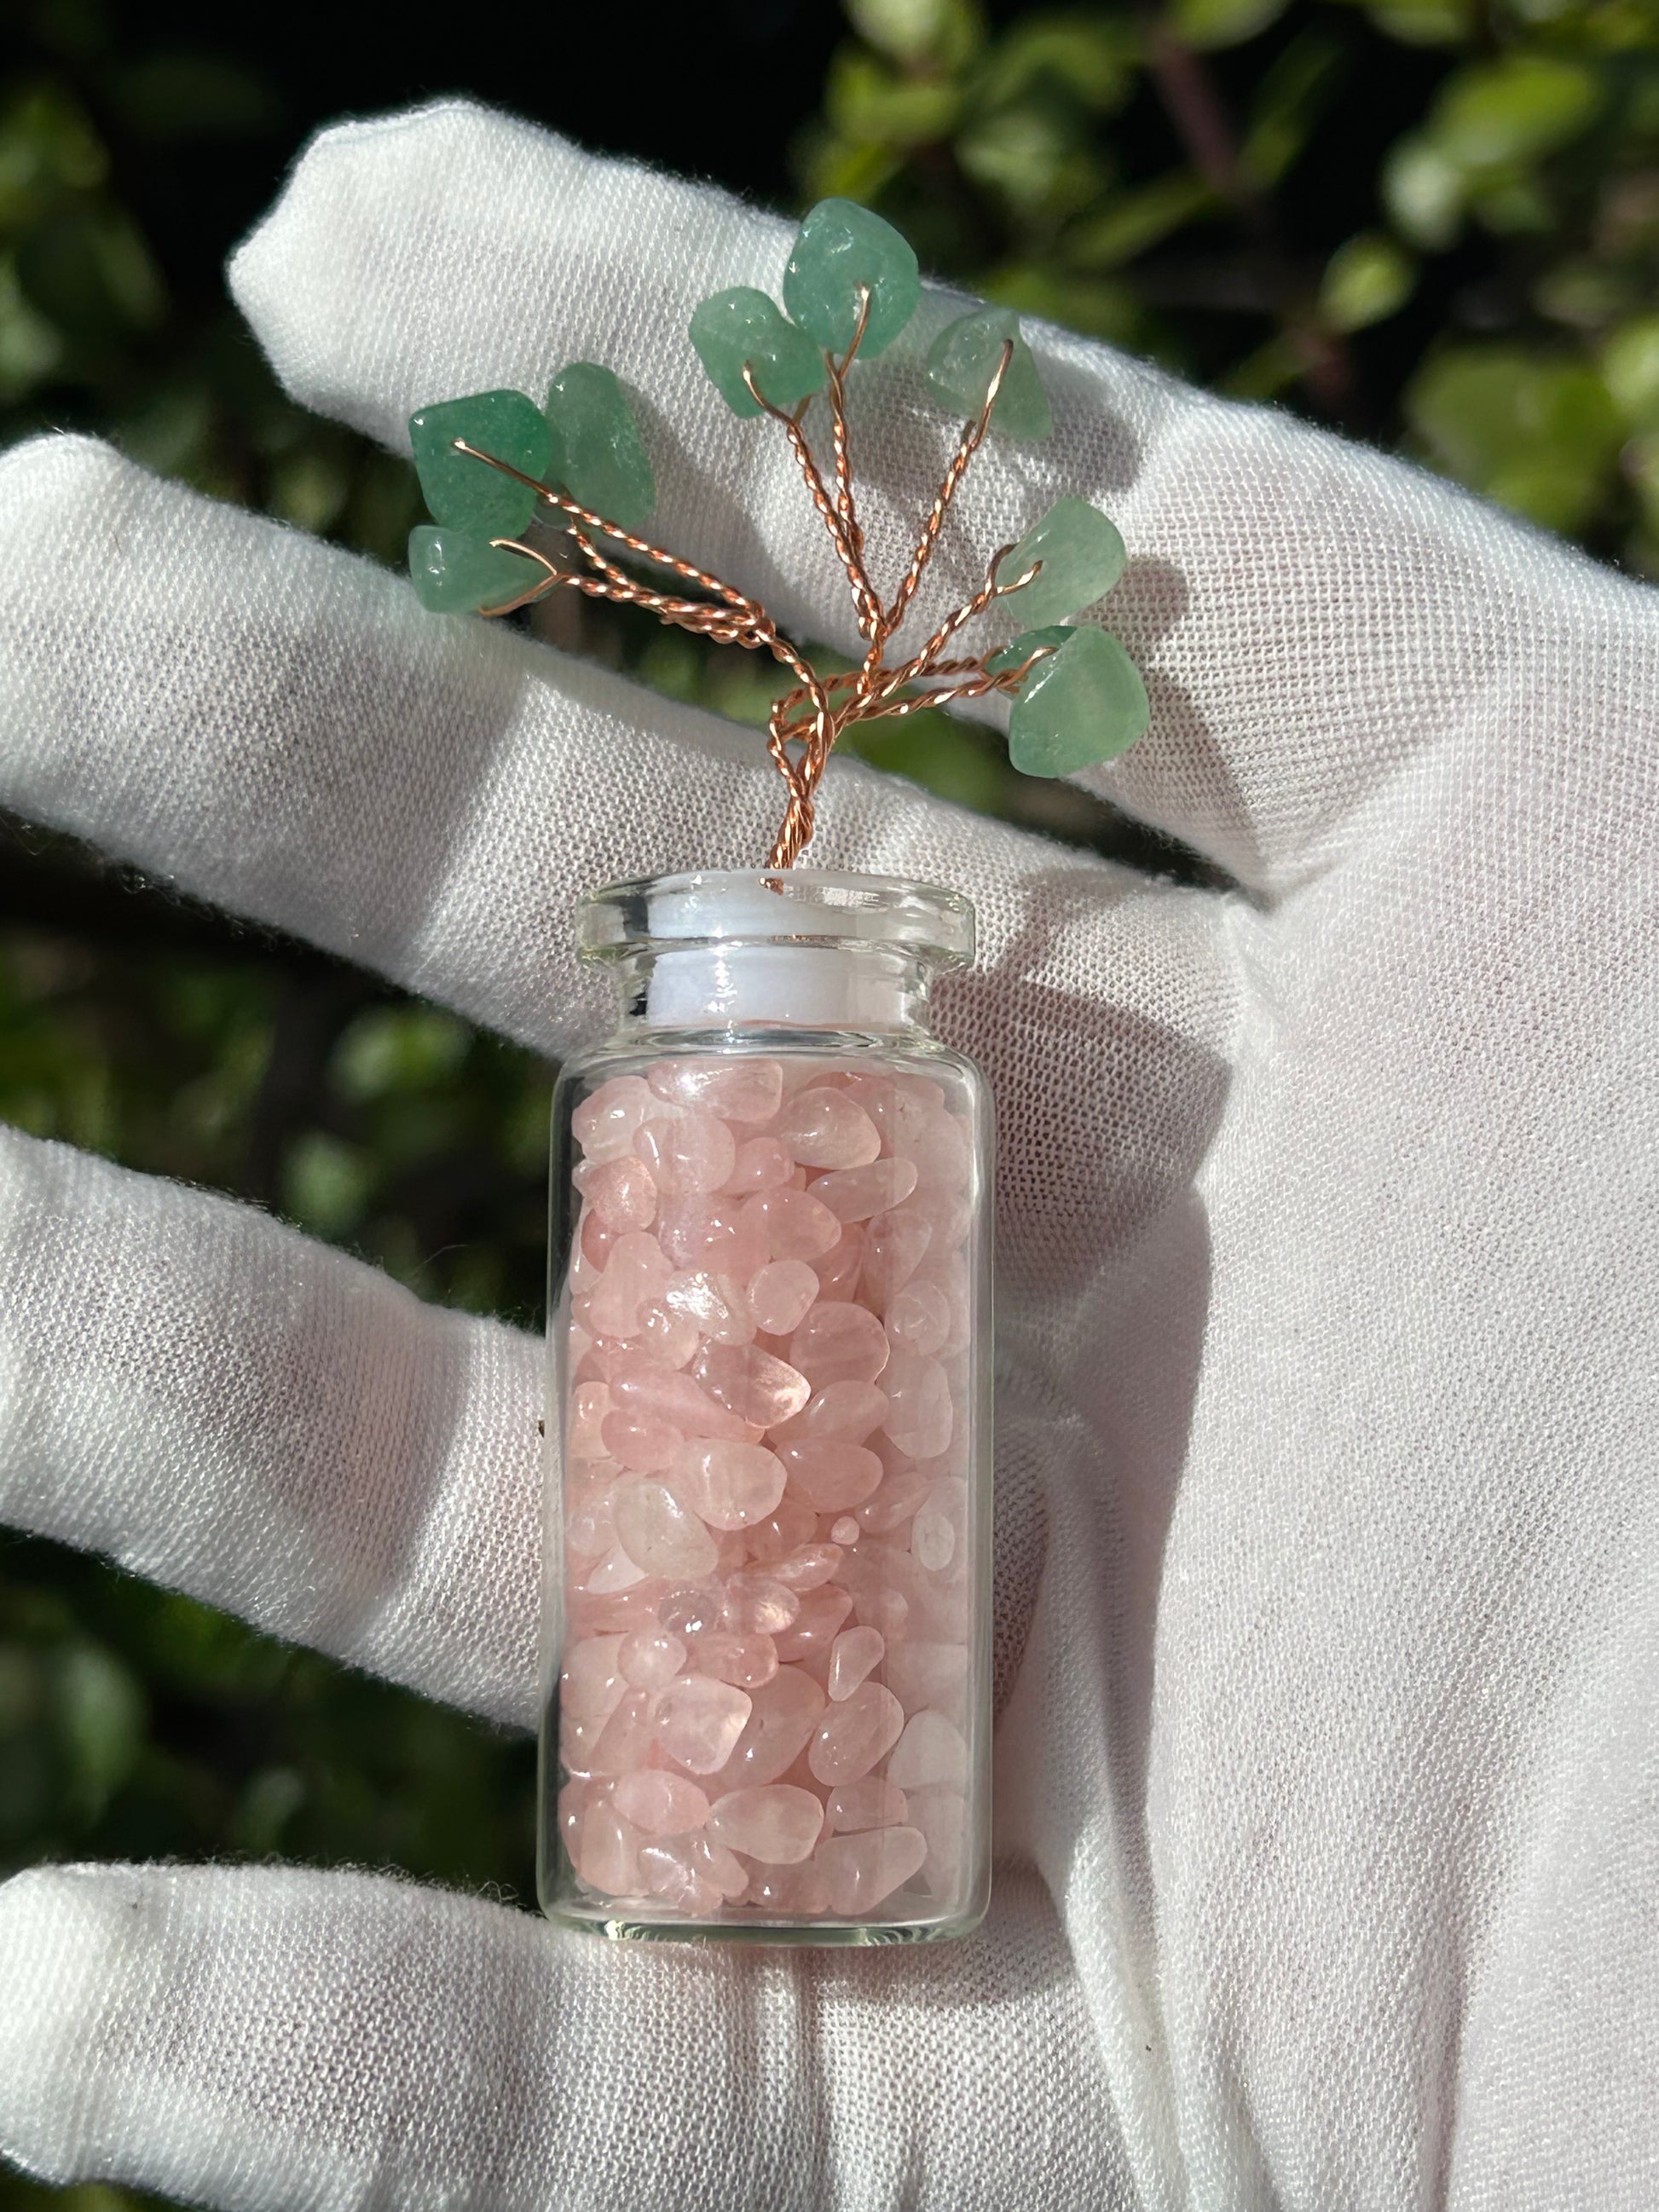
left=230, top=101, right=1650, bottom=892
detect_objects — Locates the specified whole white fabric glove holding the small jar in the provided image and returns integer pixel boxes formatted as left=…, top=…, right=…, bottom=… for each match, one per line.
left=0, top=104, right=1659, bottom=2212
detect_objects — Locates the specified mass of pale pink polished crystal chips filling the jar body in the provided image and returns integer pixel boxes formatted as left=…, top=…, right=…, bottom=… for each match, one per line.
left=555, top=1051, right=975, bottom=1925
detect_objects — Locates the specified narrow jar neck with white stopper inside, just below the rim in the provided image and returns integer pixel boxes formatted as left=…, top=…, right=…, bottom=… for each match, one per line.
left=617, top=940, right=934, bottom=1033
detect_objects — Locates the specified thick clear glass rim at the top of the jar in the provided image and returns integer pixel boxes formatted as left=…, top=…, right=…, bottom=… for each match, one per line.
left=575, top=867, right=975, bottom=967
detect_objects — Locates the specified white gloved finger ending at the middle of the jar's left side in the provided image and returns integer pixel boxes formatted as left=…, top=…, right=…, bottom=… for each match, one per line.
left=0, top=1128, right=542, bottom=1725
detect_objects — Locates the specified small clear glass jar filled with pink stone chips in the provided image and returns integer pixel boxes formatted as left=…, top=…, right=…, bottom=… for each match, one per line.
left=540, top=869, right=991, bottom=1942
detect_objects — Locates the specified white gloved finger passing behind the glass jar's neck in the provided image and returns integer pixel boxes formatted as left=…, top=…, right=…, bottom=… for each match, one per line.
left=0, top=440, right=1234, bottom=1287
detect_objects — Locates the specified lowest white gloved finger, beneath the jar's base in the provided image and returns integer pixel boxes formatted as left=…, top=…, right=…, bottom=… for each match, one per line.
left=0, top=1867, right=1132, bottom=2212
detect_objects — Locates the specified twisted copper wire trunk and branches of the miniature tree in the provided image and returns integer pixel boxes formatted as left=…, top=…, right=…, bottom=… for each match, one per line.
left=456, top=327, right=1050, bottom=867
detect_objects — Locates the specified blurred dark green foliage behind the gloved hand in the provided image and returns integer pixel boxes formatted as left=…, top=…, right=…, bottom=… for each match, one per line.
left=0, top=0, right=1659, bottom=2212
